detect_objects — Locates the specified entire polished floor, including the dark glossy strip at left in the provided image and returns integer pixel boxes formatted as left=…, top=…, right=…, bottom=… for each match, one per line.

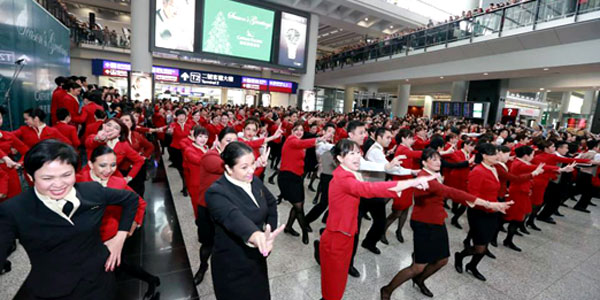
left=0, top=157, right=600, bottom=300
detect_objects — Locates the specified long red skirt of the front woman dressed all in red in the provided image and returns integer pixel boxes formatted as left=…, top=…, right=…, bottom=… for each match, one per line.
left=319, top=229, right=354, bottom=300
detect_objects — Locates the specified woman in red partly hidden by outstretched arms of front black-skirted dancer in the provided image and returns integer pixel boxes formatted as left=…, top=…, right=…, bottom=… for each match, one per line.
left=446, top=140, right=476, bottom=229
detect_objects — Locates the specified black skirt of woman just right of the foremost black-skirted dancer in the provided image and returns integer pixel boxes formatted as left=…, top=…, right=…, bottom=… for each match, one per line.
left=467, top=208, right=498, bottom=246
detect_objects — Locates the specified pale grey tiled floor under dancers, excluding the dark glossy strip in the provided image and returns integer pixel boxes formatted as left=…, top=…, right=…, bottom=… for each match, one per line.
left=167, top=162, right=600, bottom=300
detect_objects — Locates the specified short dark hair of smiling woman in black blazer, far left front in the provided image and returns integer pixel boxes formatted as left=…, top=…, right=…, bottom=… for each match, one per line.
left=23, top=139, right=77, bottom=178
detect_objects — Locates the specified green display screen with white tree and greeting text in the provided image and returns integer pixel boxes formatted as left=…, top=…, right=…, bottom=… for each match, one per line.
left=202, top=0, right=275, bottom=62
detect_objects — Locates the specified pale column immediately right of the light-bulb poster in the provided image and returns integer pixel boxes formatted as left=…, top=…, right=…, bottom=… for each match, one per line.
left=296, top=14, right=319, bottom=109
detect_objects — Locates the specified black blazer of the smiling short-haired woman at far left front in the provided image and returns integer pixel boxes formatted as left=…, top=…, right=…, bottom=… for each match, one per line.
left=0, top=182, right=138, bottom=298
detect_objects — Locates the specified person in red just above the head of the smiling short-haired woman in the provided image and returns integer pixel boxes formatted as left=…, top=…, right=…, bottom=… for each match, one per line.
left=12, top=108, right=71, bottom=148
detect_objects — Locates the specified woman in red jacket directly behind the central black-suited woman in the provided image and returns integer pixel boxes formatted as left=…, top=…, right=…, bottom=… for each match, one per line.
left=192, top=127, right=237, bottom=285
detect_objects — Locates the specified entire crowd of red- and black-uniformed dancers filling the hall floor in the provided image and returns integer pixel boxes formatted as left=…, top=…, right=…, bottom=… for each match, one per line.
left=0, top=77, right=600, bottom=300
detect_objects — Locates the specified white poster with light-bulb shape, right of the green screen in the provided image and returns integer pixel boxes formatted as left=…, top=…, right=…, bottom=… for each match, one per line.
left=278, top=12, right=308, bottom=68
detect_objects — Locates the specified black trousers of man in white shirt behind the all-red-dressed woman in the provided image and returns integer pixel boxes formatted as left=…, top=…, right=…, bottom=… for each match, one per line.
left=358, top=198, right=387, bottom=247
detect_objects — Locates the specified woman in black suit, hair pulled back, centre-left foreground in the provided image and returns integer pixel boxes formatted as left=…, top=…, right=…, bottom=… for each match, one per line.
left=205, top=142, right=284, bottom=300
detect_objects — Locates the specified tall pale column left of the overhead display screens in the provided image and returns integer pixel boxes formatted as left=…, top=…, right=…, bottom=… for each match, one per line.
left=131, top=1, right=152, bottom=73
